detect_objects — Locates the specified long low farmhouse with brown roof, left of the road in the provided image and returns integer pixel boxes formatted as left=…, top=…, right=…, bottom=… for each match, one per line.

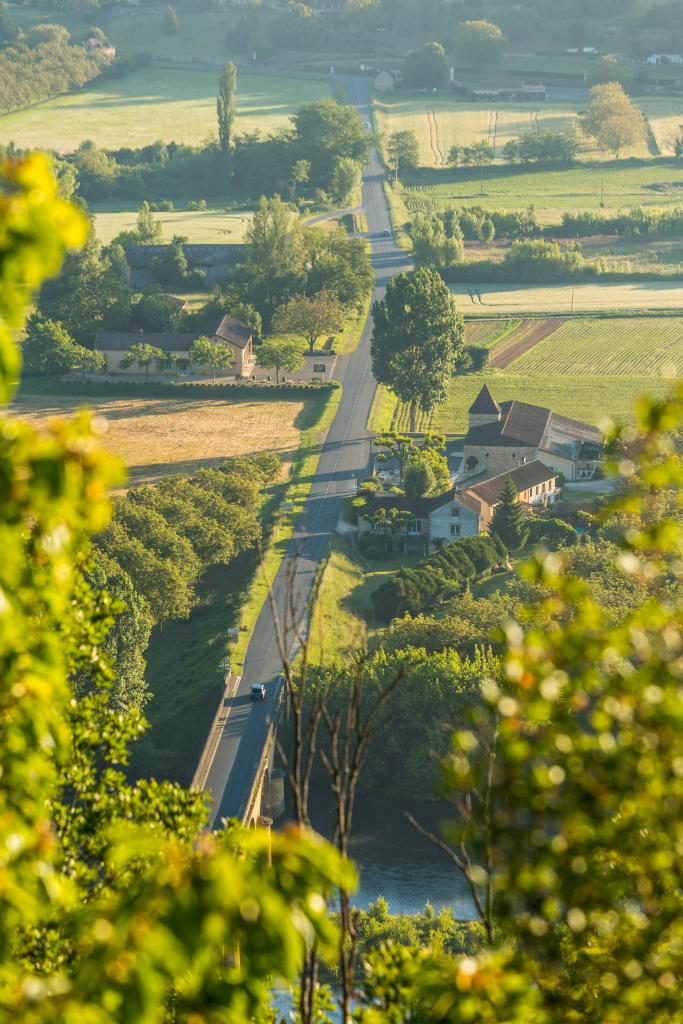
left=95, top=315, right=254, bottom=377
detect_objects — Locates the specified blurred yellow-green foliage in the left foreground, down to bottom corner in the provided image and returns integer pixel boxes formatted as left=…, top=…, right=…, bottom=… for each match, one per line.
left=0, top=142, right=354, bottom=1024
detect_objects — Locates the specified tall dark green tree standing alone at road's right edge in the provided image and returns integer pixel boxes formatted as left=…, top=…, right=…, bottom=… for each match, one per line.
left=372, top=269, right=465, bottom=432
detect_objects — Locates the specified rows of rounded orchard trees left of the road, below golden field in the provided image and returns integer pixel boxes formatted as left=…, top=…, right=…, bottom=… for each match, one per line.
left=88, top=453, right=281, bottom=709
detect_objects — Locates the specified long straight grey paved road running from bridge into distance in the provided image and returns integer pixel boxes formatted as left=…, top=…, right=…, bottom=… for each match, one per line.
left=206, top=79, right=410, bottom=825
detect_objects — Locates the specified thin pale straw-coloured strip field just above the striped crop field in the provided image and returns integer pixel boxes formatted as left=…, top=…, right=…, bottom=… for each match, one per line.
left=451, top=281, right=683, bottom=316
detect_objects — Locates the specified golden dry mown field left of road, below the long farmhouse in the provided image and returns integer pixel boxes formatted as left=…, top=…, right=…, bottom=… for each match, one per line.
left=12, top=391, right=317, bottom=484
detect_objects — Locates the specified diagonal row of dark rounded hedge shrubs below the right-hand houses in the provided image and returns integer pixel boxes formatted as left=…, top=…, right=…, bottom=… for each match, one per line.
left=372, top=534, right=508, bottom=623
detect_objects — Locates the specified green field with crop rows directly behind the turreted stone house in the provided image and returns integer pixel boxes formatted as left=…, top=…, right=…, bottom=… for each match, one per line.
left=370, top=317, right=683, bottom=434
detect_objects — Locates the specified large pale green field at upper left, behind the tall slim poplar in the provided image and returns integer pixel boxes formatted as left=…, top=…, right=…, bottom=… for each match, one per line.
left=0, top=65, right=332, bottom=153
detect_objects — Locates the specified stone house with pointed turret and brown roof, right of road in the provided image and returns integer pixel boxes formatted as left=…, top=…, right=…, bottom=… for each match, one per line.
left=462, top=386, right=604, bottom=480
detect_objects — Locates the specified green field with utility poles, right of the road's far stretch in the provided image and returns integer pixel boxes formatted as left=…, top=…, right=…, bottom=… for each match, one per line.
left=398, top=159, right=683, bottom=224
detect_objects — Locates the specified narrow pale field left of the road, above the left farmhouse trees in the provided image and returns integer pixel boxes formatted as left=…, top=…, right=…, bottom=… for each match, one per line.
left=90, top=204, right=253, bottom=245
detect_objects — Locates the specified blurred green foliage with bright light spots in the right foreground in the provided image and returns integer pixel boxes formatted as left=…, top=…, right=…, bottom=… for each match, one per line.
left=419, top=395, right=683, bottom=1024
